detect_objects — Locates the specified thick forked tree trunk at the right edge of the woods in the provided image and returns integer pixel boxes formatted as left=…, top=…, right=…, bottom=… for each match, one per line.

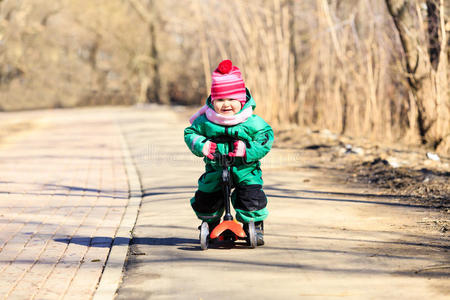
left=386, top=0, right=450, bottom=152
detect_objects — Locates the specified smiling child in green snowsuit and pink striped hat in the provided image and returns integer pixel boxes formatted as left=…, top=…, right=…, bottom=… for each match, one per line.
left=184, top=60, right=273, bottom=245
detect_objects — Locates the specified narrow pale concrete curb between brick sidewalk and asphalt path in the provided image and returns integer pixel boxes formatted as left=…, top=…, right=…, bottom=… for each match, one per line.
left=93, top=124, right=142, bottom=300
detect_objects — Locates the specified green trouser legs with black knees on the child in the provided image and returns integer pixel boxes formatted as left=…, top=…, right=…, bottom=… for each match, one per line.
left=191, top=162, right=268, bottom=223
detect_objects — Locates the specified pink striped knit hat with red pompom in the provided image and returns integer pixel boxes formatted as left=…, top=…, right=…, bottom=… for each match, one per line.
left=211, top=59, right=247, bottom=106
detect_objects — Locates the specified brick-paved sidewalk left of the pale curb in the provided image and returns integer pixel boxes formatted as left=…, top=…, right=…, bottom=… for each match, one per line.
left=0, top=108, right=129, bottom=299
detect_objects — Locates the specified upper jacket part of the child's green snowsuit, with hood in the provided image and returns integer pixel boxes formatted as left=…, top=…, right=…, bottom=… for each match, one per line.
left=184, top=90, right=273, bottom=168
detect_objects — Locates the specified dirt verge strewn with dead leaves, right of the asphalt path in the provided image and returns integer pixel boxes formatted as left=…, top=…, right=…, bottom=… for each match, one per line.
left=275, top=129, right=450, bottom=233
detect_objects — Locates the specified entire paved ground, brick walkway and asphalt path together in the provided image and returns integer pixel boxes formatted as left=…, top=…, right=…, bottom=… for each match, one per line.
left=0, top=106, right=450, bottom=299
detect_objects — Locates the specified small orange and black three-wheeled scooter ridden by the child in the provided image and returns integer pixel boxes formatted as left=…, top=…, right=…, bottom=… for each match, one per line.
left=200, top=137, right=257, bottom=250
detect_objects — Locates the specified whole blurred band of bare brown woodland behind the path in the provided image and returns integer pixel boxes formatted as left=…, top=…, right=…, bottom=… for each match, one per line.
left=0, top=0, right=450, bottom=154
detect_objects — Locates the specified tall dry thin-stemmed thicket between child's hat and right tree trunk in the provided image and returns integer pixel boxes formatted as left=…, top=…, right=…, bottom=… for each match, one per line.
left=199, top=0, right=415, bottom=143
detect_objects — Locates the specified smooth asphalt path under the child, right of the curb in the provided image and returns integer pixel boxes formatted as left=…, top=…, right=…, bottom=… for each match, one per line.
left=118, top=108, right=450, bottom=299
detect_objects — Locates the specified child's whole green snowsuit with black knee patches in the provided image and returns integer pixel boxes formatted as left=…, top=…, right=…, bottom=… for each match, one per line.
left=184, top=90, right=273, bottom=223
